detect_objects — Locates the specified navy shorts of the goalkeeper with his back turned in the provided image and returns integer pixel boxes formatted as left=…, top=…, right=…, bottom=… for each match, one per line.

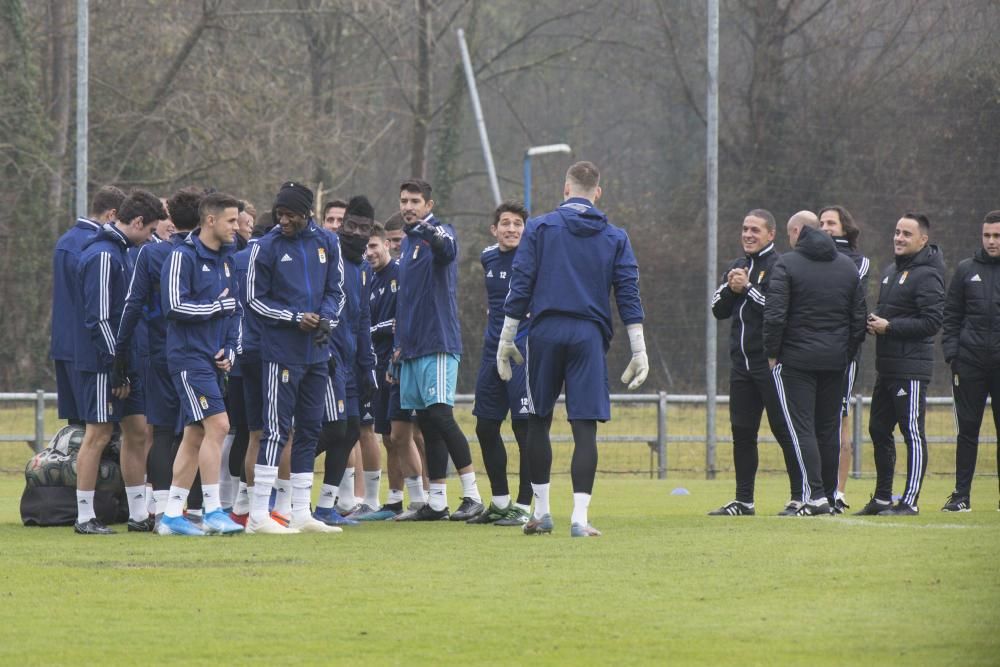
left=524, top=315, right=611, bottom=421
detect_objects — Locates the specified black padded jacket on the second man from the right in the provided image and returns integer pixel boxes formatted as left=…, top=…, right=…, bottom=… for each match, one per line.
left=875, top=245, right=944, bottom=382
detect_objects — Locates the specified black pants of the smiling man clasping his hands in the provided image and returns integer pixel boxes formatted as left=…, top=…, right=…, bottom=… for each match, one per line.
left=729, top=362, right=802, bottom=503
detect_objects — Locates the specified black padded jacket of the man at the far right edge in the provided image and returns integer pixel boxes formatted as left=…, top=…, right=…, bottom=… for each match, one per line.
left=941, top=248, right=1000, bottom=368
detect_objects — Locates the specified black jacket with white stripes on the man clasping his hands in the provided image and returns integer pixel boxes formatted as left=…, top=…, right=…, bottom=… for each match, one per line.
left=712, top=243, right=780, bottom=371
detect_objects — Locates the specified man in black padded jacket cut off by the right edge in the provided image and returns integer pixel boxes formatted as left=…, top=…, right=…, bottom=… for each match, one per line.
left=941, top=211, right=1000, bottom=512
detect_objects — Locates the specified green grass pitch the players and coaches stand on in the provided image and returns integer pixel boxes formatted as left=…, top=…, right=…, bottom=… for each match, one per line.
left=0, top=474, right=1000, bottom=667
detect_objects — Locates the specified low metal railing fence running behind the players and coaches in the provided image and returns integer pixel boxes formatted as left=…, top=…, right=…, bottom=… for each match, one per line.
left=0, top=390, right=997, bottom=479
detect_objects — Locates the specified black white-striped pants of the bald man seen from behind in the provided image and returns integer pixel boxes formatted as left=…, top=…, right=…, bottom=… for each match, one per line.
left=772, top=364, right=844, bottom=505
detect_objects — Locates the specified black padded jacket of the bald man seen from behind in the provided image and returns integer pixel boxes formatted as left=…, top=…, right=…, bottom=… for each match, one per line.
left=764, top=227, right=867, bottom=371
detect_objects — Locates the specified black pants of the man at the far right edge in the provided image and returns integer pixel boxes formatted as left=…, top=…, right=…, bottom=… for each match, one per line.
left=951, top=359, right=1000, bottom=496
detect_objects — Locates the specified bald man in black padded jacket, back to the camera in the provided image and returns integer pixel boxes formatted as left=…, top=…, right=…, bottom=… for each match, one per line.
left=764, top=211, right=865, bottom=516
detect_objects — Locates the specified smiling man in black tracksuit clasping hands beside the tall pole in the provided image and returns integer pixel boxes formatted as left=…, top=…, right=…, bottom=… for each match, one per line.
left=709, top=209, right=802, bottom=516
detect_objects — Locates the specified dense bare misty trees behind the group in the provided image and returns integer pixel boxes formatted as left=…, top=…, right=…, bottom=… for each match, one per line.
left=0, top=0, right=1000, bottom=393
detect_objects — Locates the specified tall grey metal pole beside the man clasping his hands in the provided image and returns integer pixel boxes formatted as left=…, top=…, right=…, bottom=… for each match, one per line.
left=705, top=0, right=719, bottom=479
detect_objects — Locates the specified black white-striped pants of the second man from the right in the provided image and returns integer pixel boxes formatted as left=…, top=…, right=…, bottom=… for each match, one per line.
left=868, top=376, right=928, bottom=507
